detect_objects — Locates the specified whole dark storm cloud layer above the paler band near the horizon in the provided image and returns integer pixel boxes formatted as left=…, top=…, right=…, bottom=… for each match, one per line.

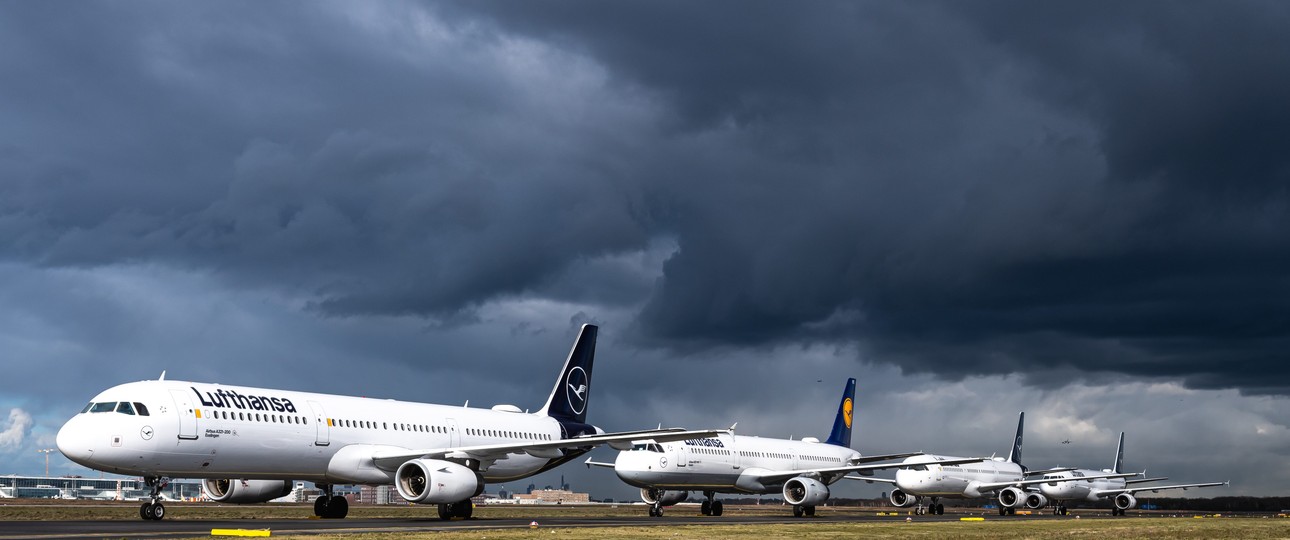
left=0, top=3, right=1290, bottom=393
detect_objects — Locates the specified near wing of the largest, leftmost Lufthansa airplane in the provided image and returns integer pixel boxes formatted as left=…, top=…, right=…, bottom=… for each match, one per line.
left=372, top=428, right=726, bottom=470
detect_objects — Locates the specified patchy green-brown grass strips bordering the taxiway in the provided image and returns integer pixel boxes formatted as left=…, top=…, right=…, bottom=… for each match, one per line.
left=0, top=499, right=1290, bottom=540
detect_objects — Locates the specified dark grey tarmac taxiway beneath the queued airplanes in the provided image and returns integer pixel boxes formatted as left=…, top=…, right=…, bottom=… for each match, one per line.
left=0, top=514, right=1088, bottom=540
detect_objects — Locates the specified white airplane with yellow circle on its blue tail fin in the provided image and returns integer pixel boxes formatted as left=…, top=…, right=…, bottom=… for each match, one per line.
left=586, top=379, right=959, bottom=517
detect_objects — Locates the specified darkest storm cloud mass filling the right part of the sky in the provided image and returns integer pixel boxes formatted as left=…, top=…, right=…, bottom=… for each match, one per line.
left=451, top=3, right=1290, bottom=393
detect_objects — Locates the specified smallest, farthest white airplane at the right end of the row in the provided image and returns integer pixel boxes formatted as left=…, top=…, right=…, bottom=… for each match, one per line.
left=1027, top=432, right=1228, bottom=516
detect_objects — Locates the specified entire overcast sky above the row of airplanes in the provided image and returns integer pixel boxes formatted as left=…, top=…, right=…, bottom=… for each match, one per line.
left=0, top=1, right=1290, bottom=497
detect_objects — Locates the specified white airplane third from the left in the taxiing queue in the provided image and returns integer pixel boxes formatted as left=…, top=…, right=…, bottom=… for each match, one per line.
left=846, top=412, right=1135, bottom=516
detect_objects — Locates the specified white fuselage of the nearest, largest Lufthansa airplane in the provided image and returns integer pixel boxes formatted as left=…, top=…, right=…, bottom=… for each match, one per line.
left=58, top=380, right=585, bottom=483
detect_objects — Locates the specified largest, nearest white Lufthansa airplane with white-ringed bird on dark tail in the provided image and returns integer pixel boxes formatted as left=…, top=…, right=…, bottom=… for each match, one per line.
left=57, top=325, right=720, bottom=521
